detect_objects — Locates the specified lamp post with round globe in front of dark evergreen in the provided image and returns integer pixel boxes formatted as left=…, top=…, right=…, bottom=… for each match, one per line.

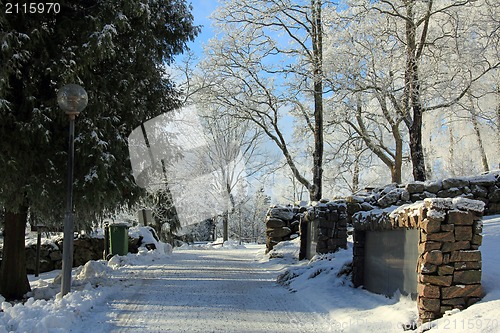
left=57, top=84, right=88, bottom=297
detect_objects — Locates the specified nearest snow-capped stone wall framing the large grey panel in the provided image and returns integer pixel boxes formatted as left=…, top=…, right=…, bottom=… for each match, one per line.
left=353, top=198, right=485, bottom=323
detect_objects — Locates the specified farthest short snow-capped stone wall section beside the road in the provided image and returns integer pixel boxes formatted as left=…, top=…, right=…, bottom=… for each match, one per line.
left=265, top=205, right=304, bottom=253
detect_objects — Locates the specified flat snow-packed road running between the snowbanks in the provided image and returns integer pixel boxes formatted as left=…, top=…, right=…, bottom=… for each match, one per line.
left=68, top=248, right=329, bottom=333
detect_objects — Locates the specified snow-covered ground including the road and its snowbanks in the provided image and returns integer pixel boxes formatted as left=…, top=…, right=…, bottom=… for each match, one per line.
left=0, top=216, right=500, bottom=333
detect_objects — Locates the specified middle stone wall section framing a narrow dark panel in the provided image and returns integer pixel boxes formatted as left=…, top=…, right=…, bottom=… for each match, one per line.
left=300, top=200, right=347, bottom=259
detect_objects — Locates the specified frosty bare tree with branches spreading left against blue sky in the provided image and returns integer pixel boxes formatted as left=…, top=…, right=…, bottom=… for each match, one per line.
left=205, top=0, right=332, bottom=200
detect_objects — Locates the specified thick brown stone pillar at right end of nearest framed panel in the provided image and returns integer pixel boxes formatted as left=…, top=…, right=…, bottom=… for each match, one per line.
left=417, top=199, right=484, bottom=323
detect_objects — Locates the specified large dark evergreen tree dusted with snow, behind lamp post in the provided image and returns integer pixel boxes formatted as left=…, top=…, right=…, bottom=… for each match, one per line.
left=0, top=0, right=198, bottom=299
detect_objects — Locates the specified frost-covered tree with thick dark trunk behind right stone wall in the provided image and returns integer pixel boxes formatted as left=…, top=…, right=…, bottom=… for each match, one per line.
left=324, top=0, right=499, bottom=180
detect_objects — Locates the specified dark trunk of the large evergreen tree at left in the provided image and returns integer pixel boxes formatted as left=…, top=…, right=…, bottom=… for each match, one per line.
left=0, top=207, right=31, bottom=300
